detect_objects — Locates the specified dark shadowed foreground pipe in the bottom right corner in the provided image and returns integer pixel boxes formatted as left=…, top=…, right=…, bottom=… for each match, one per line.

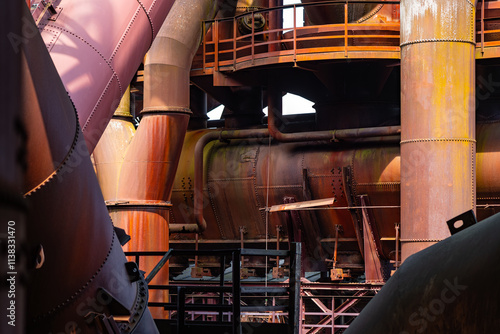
left=346, top=214, right=500, bottom=334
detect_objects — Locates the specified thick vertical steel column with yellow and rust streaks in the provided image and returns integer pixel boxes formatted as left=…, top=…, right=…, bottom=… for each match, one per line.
left=401, top=0, right=476, bottom=261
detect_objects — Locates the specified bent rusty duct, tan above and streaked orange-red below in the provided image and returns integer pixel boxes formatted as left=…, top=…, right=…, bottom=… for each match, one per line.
left=110, top=0, right=216, bottom=313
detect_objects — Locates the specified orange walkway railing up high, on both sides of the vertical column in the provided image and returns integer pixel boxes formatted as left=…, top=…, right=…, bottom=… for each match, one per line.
left=193, top=0, right=500, bottom=74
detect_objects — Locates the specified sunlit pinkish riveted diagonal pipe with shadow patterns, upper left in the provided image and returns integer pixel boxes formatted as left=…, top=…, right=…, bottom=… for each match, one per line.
left=37, top=0, right=174, bottom=152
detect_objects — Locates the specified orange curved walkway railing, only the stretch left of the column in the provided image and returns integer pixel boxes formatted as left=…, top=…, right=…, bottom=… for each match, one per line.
left=197, top=0, right=400, bottom=74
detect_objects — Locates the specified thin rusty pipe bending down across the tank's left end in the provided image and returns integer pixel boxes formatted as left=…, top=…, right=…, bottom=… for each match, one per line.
left=170, top=129, right=269, bottom=233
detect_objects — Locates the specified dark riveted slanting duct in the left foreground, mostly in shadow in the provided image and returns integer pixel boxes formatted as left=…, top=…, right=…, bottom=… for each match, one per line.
left=22, top=4, right=157, bottom=333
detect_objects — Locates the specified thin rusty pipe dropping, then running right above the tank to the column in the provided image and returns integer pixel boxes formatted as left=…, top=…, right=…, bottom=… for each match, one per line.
left=267, top=84, right=401, bottom=143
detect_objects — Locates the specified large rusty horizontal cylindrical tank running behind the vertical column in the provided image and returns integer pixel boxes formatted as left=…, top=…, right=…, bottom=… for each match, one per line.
left=170, top=123, right=500, bottom=269
